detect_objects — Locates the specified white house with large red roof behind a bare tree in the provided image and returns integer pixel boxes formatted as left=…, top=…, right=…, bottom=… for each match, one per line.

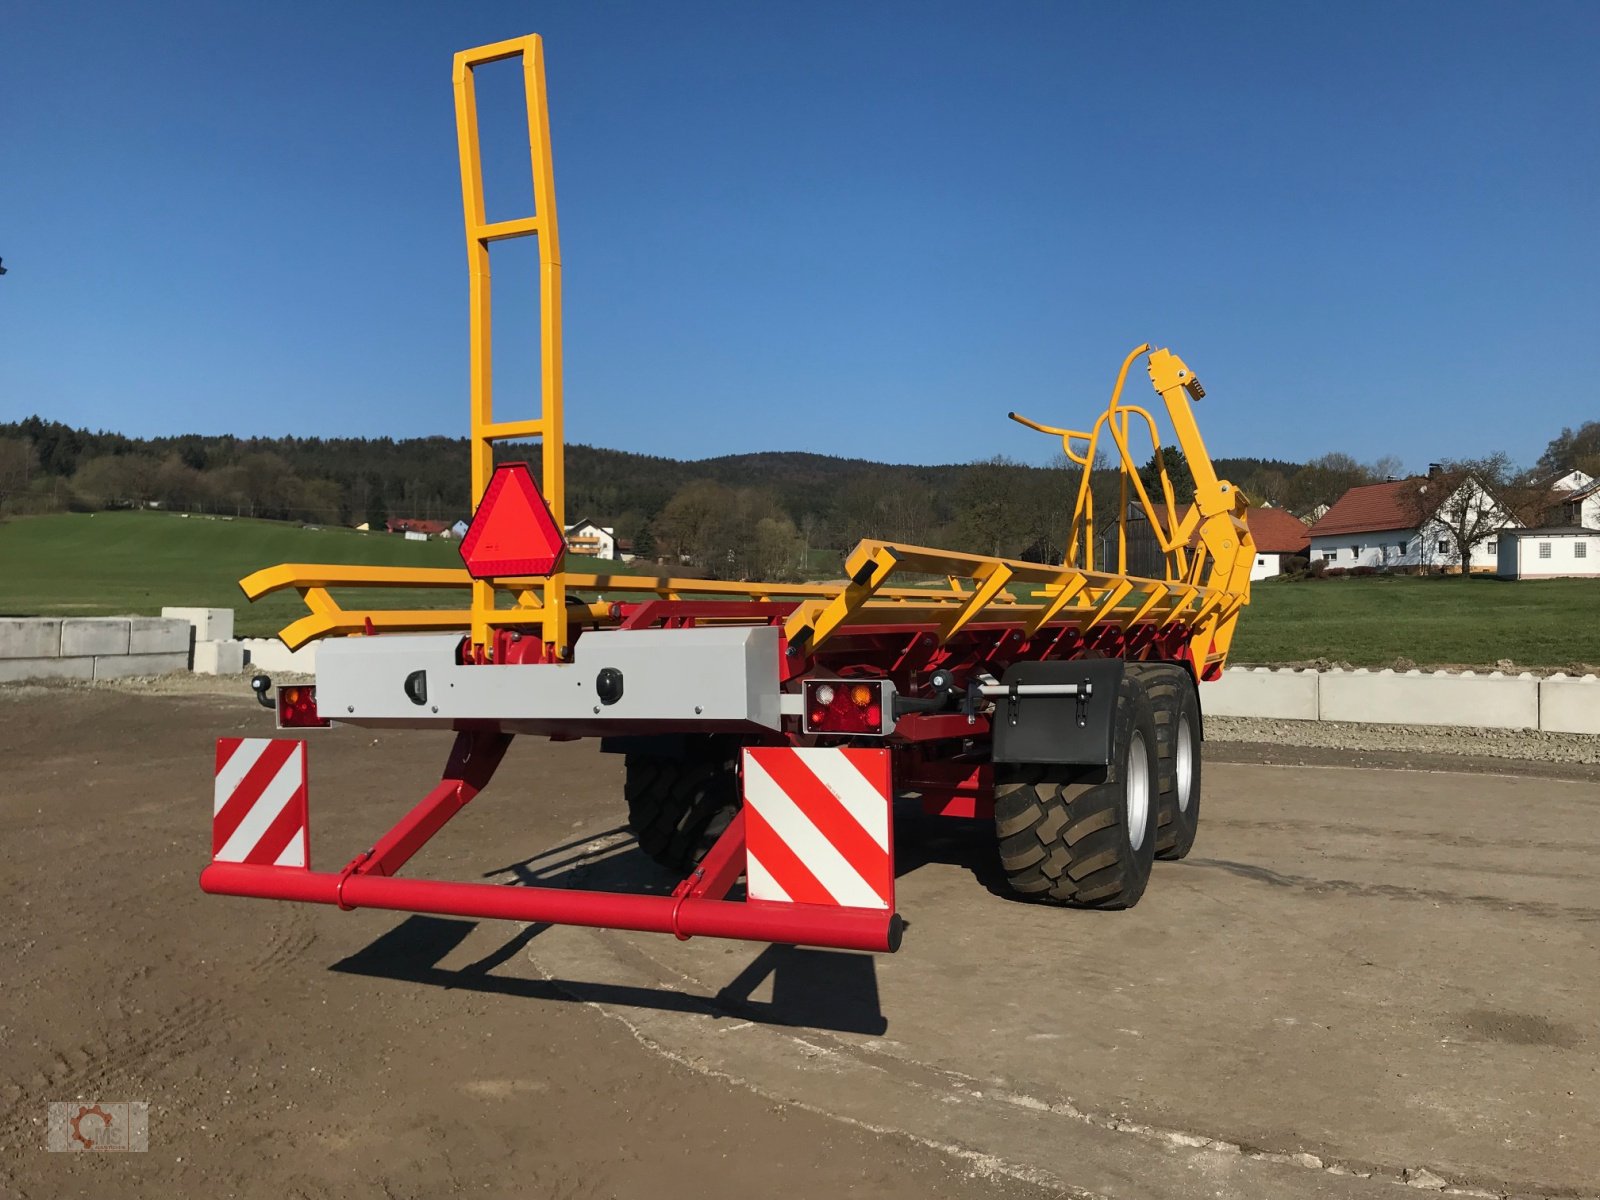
left=1310, top=475, right=1522, bottom=571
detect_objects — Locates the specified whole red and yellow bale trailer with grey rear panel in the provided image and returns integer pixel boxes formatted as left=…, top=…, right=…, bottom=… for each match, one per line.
left=200, top=37, right=1254, bottom=950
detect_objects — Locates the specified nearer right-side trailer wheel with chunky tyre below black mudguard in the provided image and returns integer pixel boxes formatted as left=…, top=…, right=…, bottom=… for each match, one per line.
left=995, top=674, right=1157, bottom=909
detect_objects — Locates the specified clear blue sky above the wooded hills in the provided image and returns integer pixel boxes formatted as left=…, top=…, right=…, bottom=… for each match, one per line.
left=0, top=0, right=1600, bottom=467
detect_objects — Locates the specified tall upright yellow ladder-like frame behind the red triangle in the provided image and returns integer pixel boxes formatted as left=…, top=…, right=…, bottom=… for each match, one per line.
left=454, top=34, right=566, bottom=654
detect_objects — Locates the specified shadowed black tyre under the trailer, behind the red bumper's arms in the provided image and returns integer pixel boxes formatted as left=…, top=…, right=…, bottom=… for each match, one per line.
left=624, top=734, right=741, bottom=875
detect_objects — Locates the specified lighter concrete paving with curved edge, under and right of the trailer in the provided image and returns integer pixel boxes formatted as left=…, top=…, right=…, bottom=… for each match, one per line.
left=515, top=763, right=1600, bottom=1200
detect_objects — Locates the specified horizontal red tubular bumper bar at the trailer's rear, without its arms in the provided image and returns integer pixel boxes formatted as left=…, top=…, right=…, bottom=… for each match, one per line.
left=200, top=862, right=902, bottom=952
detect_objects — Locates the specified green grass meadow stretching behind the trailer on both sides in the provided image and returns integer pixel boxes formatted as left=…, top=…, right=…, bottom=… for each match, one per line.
left=0, top=512, right=1600, bottom=667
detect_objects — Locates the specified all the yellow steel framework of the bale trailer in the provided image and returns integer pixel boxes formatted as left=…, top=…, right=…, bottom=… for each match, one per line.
left=240, top=37, right=1254, bottom=672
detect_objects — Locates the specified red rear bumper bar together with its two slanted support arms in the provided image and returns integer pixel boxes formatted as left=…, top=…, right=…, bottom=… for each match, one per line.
left=200, top=731, right=902, bottom=952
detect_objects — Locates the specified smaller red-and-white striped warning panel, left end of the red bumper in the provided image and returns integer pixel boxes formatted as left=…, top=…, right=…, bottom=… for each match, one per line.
left=211, top=738, right=310, bottom=867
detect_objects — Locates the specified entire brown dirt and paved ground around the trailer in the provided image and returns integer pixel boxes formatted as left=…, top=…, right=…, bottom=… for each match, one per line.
left=0, top=688, right=1600, bottom=1200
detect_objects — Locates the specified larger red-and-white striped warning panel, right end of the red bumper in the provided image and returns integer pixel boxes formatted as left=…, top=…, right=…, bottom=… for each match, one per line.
left=744, top=746, right=894, bottom=909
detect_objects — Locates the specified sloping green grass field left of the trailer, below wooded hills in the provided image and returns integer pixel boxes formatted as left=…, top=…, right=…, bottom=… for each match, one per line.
left=0, top=512, right=626, bottom=637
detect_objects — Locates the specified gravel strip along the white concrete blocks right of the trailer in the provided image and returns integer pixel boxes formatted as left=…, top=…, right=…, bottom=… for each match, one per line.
left=1205, top=717, right=1600, bottom=765
